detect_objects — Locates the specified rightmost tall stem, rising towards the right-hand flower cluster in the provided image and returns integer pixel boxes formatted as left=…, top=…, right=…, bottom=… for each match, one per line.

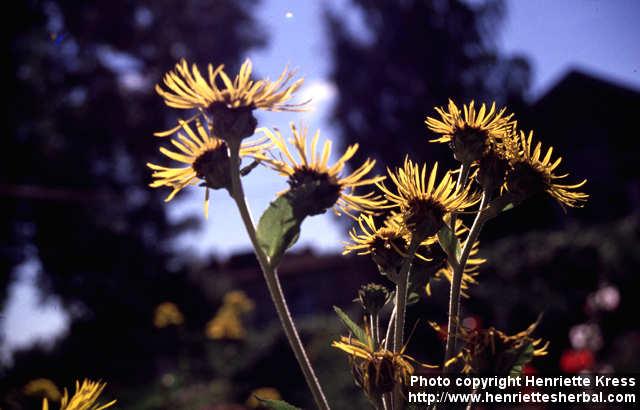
left=444, top=191, right=490, bottom=373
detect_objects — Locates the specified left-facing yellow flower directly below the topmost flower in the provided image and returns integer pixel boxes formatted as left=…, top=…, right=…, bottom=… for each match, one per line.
left=147, top=120, right=269, bottom=216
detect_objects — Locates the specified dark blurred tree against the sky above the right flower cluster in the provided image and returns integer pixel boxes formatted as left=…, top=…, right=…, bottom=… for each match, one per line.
left=328, top=0, right=529, bottom=165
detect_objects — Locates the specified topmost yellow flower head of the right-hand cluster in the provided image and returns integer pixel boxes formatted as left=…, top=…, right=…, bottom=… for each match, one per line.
left=425, top=100, right=515, bottom=163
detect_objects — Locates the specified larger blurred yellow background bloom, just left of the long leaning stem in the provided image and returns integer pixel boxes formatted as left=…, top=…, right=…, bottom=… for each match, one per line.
left=205, top=291, right=255, bottom=340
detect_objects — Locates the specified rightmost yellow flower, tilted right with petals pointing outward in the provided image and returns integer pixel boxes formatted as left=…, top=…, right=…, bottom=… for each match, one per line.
left=506, top=131, right=589, bottom=208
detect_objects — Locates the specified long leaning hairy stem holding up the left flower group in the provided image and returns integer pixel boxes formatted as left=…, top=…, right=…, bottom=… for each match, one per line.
left=229, top=139, right=329, bottom=410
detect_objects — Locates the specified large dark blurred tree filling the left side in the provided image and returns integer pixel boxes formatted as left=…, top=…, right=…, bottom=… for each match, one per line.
left=0, top=0, right=264, bottom=408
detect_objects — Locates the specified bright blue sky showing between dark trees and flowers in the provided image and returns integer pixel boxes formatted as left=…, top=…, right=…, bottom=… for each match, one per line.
left=0, top=0, right=640, bottom=362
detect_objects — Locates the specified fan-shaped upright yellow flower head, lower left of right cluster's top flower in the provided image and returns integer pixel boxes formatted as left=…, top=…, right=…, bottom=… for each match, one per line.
left=377, top=157, right=479, bottom=241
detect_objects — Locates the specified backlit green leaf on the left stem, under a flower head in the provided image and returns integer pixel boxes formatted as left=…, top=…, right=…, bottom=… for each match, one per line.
left=257, top=195, right=302, bottom=268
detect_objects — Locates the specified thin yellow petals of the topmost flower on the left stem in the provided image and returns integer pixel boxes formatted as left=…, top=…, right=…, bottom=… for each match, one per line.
left=156, top=59, right=304, bottom=111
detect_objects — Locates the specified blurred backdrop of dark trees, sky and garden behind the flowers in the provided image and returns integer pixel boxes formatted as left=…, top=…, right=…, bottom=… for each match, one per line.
left=5, top=0, right=640, bottom=410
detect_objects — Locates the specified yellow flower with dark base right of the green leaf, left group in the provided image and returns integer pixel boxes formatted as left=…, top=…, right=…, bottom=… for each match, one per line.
left=262, top=123, right=385, bottom=215
